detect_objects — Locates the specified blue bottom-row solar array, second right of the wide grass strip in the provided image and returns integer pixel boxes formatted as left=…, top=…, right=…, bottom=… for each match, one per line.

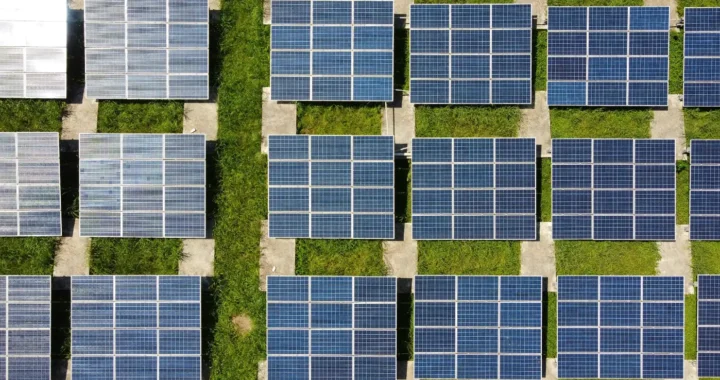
left=414, top=276, right=543, bottom=379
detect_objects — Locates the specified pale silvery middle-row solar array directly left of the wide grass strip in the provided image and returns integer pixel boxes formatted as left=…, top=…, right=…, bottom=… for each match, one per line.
left=80, top=133, right=205, bottom=238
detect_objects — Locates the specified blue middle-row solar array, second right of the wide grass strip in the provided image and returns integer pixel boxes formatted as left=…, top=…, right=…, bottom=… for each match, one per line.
left=412, top=138, right=537, bottom=240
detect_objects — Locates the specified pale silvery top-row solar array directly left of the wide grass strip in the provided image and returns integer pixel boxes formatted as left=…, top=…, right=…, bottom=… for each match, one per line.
left=85, top=0, right=209, bottom=99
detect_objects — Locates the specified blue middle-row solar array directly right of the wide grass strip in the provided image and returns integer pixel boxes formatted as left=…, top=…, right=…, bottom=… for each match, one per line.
left=268, top=135, right=395, bottom=239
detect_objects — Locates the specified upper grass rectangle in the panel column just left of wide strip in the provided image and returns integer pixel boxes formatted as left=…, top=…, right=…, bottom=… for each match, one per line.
left=98, top=101, right=184, bottom=133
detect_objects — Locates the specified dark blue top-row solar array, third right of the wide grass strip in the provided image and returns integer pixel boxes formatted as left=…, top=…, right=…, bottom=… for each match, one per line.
left=547, top=7, right=670, bottom=107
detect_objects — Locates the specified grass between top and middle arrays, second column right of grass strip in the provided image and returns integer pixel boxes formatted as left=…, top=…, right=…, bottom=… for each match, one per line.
left=415, top=106, right=522, bottom=137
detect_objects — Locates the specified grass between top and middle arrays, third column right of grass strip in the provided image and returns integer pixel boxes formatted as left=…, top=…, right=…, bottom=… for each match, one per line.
left=550, top=108, right=653, bottom=138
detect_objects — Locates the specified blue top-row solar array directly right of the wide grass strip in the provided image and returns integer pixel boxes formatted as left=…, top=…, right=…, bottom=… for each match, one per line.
left=270, top=0, right=394, bottom=102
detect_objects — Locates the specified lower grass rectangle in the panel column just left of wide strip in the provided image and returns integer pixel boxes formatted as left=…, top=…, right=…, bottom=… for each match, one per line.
left=90, top=238, right=182, bottom=275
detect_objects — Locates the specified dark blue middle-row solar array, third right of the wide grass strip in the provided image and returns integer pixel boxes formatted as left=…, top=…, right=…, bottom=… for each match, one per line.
left=552, top=139, right=675, bottom=240
